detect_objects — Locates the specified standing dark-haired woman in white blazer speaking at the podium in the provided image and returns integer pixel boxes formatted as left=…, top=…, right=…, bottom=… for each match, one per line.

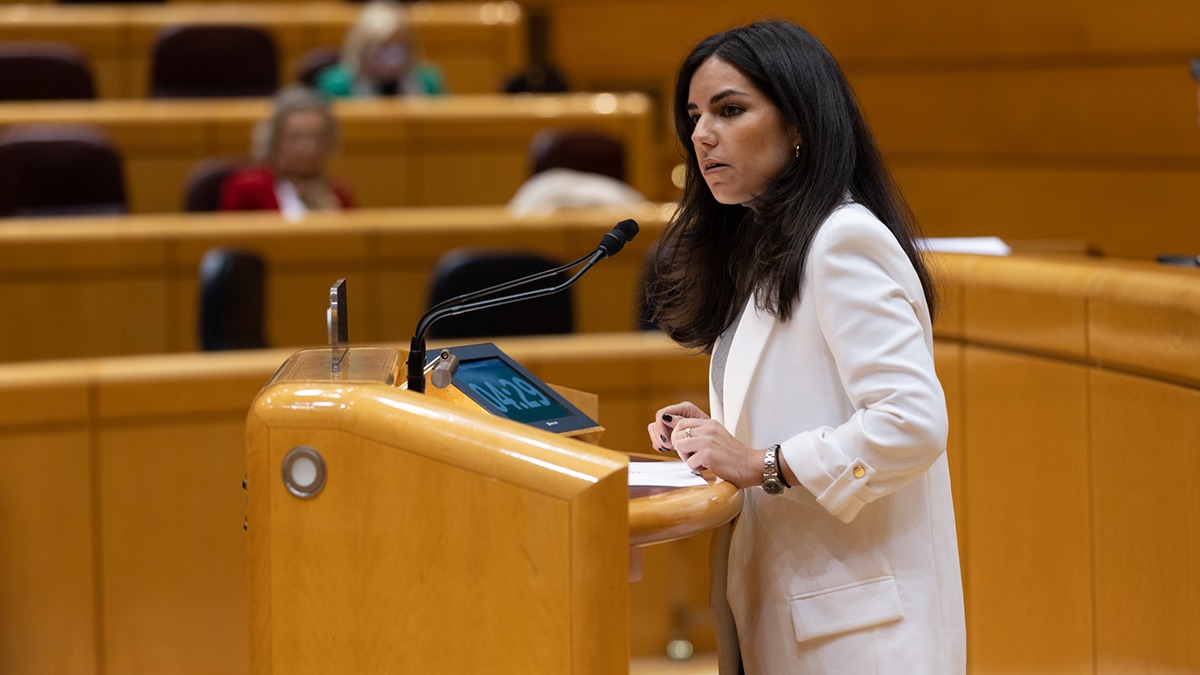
left=649, top=22, right=966, bottom=675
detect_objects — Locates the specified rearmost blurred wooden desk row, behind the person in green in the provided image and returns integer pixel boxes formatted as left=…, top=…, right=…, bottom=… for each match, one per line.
left=0, top=2, right=528, bottom=98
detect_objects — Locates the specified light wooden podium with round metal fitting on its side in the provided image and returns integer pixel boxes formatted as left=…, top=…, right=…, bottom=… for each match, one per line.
left=247, top=348, right=740, bottom=675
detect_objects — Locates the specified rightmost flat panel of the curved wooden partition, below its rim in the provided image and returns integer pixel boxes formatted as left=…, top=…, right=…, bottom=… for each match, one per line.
left=1088, top=372, right=1200, bottom=675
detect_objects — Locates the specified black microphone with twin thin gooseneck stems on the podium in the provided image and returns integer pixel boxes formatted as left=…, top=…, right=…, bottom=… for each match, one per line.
left=408, top=219, right=638, bottom=394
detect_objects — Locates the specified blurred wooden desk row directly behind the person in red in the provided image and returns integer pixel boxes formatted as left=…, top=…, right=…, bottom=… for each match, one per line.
left=0, top=94, right=665, bottom=213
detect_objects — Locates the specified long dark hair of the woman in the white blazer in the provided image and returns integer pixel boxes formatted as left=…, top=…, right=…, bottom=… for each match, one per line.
left=648, top=22, right=936, bottom=350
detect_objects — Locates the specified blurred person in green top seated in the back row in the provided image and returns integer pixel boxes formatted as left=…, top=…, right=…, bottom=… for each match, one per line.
left=317, top=0, right=445, bottom=97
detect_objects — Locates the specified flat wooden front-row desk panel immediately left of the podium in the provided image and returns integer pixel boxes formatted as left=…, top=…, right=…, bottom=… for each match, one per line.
left=97, top=420, right=250, bottom=674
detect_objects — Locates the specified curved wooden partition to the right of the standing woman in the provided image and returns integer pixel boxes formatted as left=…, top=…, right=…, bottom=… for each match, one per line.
left=937, top=251, right=1200, bottom=675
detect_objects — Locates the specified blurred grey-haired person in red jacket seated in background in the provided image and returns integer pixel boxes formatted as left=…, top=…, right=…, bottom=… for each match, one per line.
left=221, top=85, right=352, bottom=219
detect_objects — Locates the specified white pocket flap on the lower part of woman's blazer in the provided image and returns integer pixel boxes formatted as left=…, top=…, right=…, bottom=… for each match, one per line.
left=791, top=577, right=904, bottom=643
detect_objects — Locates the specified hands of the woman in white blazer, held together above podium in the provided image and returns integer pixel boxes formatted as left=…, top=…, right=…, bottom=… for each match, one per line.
left=647, top=402, right=762, bottom=488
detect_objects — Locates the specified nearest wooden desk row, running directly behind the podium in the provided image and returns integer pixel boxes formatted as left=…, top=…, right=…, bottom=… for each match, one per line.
left=0, top=334, right=713, bottom=675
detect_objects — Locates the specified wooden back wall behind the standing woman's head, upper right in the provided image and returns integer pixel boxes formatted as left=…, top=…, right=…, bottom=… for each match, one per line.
left=537, top=0, right=1200, bottom=259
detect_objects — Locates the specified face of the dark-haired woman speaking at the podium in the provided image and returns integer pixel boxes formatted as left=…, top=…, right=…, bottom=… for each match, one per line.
left=688, top=56, right=800, bottom=205
